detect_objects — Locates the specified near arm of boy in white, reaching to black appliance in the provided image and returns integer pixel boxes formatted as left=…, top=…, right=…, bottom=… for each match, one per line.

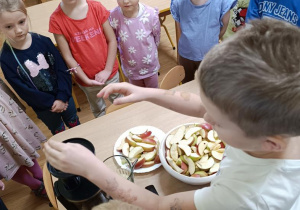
left=44, top=140, right=196, bottom=209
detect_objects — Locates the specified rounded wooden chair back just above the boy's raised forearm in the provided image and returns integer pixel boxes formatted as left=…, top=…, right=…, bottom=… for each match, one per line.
left=159, top=65, right=185, bottom=90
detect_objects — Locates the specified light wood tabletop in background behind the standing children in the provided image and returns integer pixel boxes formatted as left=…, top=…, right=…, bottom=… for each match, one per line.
left=27, top=0, right=171, bottom=44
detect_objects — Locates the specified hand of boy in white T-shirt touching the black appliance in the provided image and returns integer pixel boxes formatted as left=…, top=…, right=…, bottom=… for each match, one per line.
left=43, top=140, right=99, bottom=177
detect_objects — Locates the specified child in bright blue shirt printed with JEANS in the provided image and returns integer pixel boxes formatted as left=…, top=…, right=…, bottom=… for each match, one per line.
left=246, top=0, right=300, bottom=27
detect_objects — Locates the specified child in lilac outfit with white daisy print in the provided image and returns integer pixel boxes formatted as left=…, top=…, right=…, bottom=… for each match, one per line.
left=110, top=0, right=160, bottom=88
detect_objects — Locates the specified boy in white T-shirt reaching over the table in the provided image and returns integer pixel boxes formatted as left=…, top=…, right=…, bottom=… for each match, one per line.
left=45, top=19, right=300, bottom=210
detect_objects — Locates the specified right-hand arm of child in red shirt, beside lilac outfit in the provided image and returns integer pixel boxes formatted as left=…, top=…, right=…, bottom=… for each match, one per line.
left=95, top=20, right=117, bottom=83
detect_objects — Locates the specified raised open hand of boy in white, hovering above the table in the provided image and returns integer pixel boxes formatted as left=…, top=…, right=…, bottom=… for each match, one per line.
left=97, top=82, right=146, bottom=105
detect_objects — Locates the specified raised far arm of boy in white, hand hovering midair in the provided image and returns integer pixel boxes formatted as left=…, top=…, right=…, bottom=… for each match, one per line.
left=97, top=82, right=205, bottom=117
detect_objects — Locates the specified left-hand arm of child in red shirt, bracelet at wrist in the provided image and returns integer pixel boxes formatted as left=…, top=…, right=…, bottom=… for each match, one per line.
left=54, top=34, right=103, bottom=86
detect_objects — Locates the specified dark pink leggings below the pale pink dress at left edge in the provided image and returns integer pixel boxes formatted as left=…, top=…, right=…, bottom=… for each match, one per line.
left=12, top=159, right=46, bottom=193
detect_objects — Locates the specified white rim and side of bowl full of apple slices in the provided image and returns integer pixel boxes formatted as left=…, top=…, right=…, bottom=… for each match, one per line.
left=159, top=123, right=216, bottom=185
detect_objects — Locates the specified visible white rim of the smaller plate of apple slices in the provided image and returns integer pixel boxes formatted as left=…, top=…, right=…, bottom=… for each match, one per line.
left=114, top=125, right=166, bottom=173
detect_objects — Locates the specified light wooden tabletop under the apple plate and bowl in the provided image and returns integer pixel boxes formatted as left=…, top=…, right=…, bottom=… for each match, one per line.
left=51, top=81, right=207, bottom=210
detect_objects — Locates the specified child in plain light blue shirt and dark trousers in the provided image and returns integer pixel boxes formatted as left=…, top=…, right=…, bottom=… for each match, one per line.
left=170, top=0, right=236, bottom=83
